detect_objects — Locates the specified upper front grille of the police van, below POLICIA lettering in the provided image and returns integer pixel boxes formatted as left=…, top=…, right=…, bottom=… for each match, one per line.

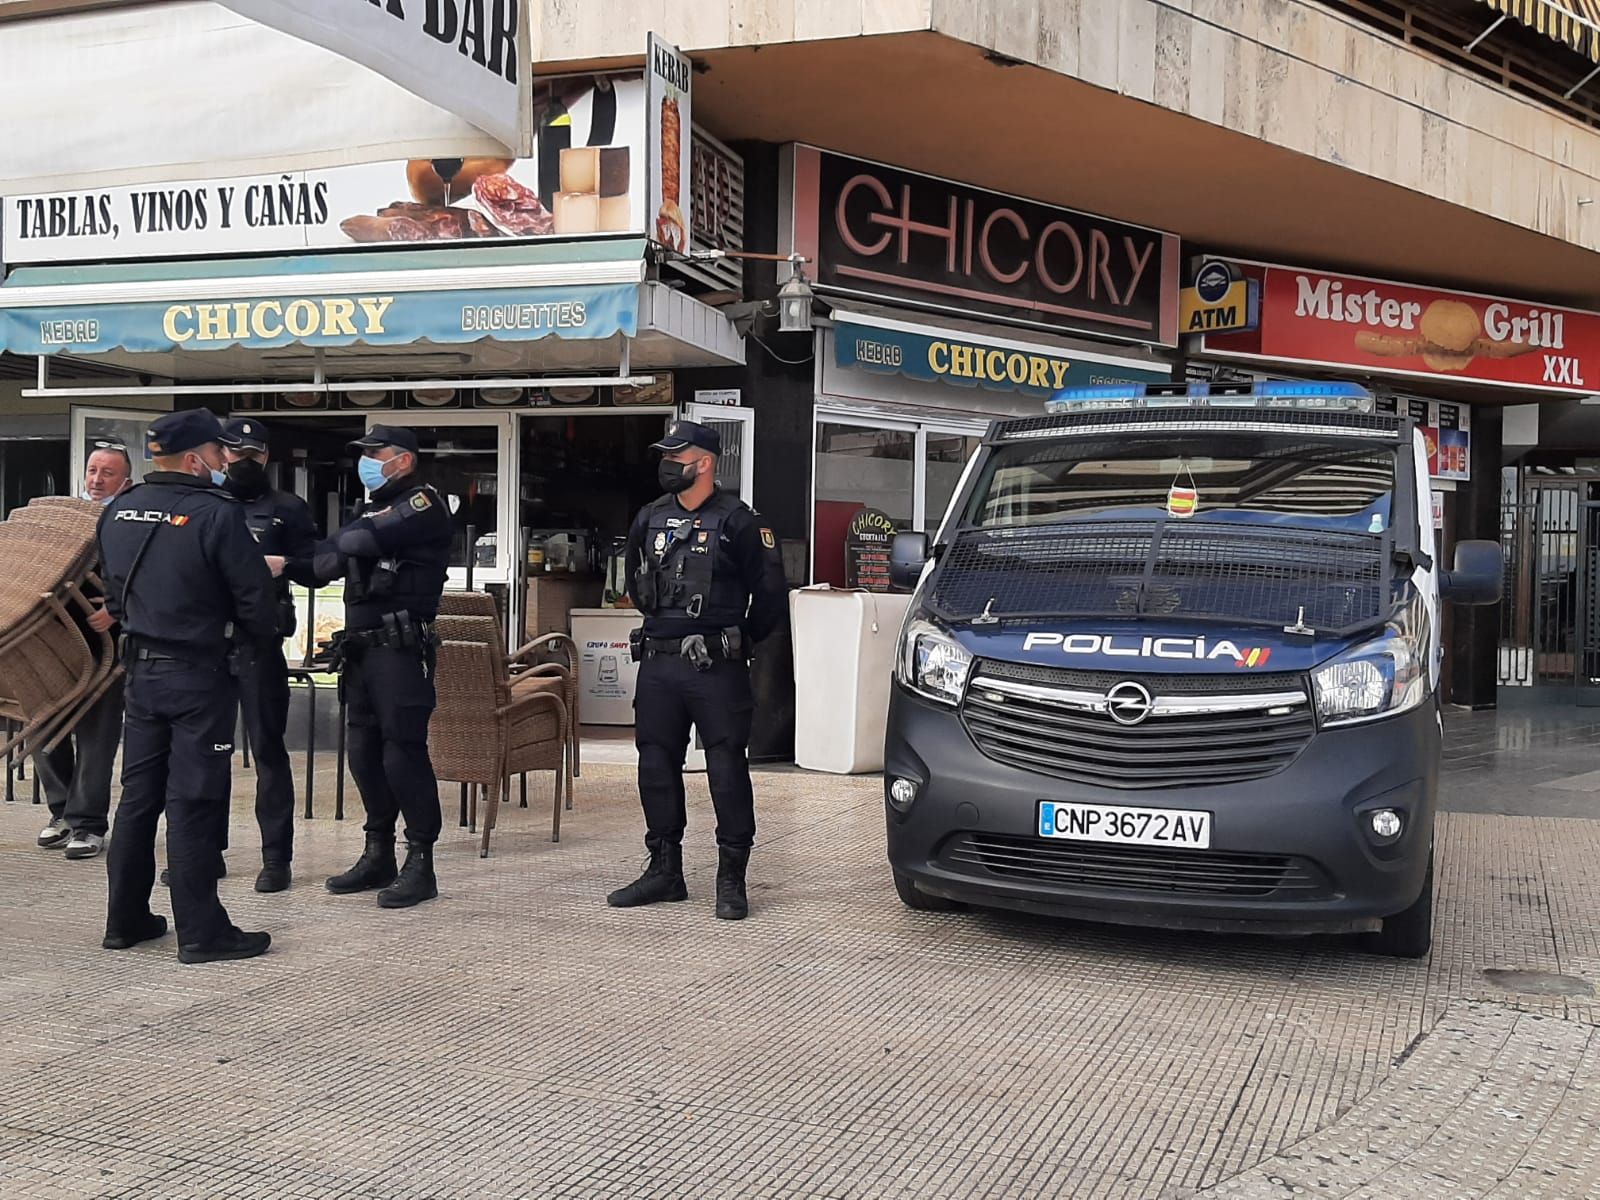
left=962, top=662, right=1317, bottom=790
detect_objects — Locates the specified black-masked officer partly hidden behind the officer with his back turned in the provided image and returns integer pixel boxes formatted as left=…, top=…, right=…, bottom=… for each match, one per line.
left=224, top=418, right=317, bottom=891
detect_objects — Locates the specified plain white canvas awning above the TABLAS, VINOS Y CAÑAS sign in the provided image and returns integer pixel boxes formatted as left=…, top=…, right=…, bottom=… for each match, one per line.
left=0, top=0, right=505, bottom=195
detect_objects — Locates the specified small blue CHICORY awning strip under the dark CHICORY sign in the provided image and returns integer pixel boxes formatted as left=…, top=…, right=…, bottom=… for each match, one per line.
left=834, top=320, right=1171, bottom=398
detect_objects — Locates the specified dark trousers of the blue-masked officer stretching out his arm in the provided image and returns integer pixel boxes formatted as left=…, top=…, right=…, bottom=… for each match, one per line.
left=341, top=646, right=441, bottom=846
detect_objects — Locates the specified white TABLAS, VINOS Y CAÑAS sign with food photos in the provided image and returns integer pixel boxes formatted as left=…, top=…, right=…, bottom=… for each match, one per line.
left=0, top=72, right=649, bottom=264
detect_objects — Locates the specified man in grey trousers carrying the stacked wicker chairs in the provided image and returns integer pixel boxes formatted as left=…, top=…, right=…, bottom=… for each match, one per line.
left=37, top=443, right=133, bottom=859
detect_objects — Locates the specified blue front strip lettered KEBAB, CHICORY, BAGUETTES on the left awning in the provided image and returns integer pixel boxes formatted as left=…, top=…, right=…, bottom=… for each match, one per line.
left=0, top=283, right=638, bottom=354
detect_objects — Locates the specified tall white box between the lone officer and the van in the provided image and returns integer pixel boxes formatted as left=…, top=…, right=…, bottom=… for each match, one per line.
left=789, top=586, right=910, bottom=774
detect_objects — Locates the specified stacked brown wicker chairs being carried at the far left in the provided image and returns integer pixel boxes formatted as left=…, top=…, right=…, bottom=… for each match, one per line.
left=0, top=496, right=122, bottom=755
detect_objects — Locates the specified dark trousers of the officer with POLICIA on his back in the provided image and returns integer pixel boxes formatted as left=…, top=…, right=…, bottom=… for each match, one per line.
left=106, top=661, right=238, bottom=946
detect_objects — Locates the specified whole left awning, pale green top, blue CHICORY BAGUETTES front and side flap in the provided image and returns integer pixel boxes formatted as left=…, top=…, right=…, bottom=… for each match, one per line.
left=0, top=240, right=744, bottom=378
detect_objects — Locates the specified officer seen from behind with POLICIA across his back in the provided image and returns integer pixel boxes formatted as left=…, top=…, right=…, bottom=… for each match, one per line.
left=99, top=408, right=277, bottom=963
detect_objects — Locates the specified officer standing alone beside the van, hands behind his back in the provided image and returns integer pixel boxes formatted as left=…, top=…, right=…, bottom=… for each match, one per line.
left=606, top=421, right=787, bottom=920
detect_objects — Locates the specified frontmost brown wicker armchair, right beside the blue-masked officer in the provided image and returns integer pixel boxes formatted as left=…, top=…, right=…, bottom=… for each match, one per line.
left=429, top=640, right=573, bottom=858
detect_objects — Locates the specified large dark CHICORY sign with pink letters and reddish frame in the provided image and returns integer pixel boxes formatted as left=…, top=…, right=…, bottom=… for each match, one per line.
left=794, top=146, right=1179, bottom=346
